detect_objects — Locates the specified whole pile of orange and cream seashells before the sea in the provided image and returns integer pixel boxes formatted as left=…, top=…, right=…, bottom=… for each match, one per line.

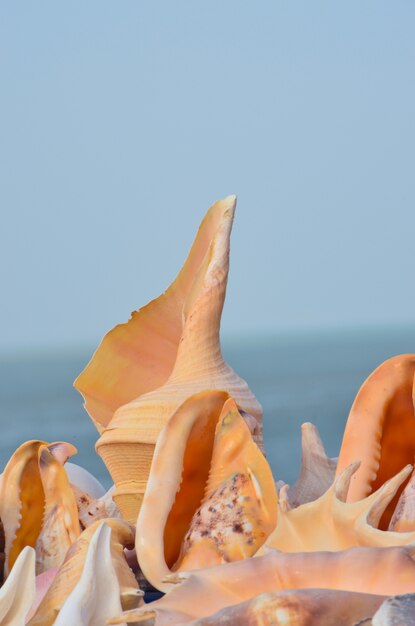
left=0, top=196, right=415, bottom=626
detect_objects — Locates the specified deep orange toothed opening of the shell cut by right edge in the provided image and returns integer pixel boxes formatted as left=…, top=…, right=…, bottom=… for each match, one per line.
left=370, top=382, right=415, bottom=530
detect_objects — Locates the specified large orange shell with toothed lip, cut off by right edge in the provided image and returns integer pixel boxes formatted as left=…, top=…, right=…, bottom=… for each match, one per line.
left=337, top=354, right=415, bottom=528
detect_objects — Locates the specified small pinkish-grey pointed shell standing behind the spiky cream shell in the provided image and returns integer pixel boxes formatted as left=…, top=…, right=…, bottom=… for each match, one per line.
left=288, top=422, right=337, bottom=508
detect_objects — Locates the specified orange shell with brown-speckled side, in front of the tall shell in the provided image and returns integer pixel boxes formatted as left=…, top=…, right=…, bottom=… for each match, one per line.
left=136, top=390, right=277, bottom=591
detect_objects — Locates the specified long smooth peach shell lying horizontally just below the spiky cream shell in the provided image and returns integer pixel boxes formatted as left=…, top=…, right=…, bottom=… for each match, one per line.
left=109, top=547, right=415, bottom=626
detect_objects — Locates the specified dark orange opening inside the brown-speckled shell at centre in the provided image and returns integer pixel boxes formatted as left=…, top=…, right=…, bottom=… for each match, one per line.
left=164, top=403, right=228, bottom=569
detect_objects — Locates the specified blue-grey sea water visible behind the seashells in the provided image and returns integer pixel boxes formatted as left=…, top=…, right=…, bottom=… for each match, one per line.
left=0, top=327, right=415, bottom=486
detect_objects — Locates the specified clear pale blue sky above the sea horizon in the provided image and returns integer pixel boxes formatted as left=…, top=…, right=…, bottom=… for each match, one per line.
left=0, top=0, right=415, bottom=351
